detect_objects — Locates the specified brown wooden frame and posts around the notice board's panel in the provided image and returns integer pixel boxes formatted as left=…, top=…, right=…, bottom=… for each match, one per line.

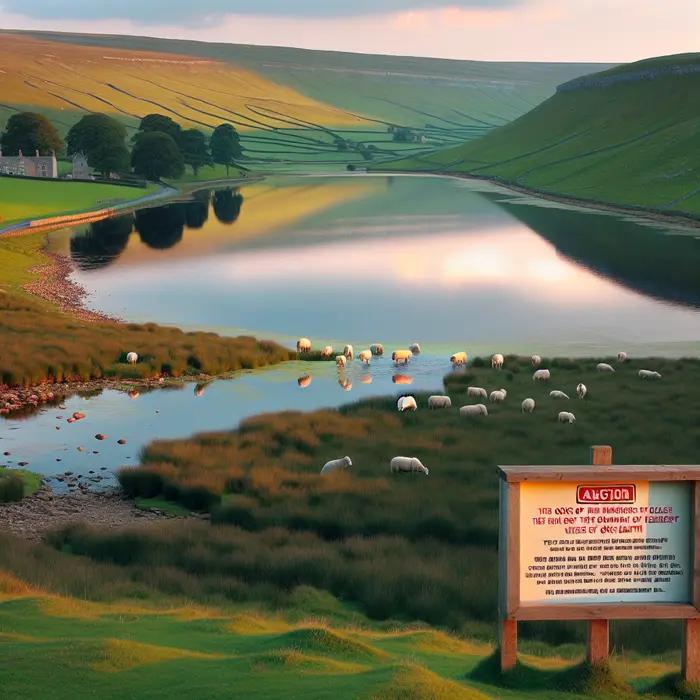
left=498, top=446, right=700, bottom=681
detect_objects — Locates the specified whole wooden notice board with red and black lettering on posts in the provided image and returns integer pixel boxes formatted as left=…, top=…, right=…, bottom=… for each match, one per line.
left=498, top=447, right=700, bottom=681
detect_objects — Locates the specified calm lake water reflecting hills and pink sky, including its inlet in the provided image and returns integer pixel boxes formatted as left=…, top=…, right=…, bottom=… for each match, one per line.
left=0, top=176, right=700, bottom=476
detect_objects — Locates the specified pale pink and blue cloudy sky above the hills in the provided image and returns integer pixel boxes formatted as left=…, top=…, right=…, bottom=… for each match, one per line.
left=0, top=0, right=700, bottom=63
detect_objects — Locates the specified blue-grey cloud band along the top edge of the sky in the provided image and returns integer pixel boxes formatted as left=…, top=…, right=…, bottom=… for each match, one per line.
left=0, top=0, right=527, bottom=26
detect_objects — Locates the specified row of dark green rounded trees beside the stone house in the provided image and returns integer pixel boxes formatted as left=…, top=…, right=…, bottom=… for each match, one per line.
left=0, top=112, right=243, bottom=180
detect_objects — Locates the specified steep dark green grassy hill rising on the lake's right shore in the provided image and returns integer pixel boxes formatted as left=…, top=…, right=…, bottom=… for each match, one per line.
left=390, top=54, right=700, bottom=215
